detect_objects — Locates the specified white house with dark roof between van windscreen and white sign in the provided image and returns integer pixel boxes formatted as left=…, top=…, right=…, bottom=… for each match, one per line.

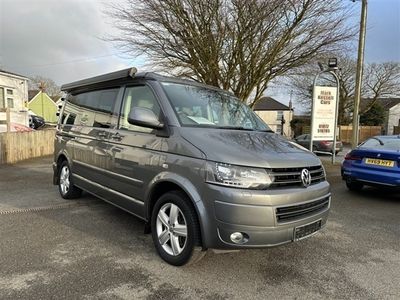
left=253, top=97, right=293, bottom=137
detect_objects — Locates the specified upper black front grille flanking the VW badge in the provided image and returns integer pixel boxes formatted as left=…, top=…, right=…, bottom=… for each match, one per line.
left=271, top=166, right=325, bottom=187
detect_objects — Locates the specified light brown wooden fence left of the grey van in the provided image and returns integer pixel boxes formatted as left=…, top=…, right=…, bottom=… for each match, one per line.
left=0, top=129, right=55, bottom=164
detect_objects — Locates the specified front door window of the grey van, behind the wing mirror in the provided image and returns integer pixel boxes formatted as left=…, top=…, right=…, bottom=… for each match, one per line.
left=119, top=85, right=161, bottom=132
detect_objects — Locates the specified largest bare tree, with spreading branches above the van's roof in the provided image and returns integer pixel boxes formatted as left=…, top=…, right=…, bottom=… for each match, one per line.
left=107, top=0, right=354, bottom=106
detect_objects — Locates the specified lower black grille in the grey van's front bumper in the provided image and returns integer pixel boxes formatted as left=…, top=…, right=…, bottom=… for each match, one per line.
left=275, top=196, right=330, bottom=223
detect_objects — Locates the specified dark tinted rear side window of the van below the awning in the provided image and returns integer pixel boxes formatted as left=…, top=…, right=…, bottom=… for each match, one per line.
left=64, top=88, right=119, bottom=128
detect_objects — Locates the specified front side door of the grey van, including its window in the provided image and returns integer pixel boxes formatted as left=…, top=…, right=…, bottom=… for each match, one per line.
left=104, top=85, right=165, bottom=217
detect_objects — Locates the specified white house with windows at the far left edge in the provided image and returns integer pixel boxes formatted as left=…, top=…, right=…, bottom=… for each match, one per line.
left=0, top=69, right=29, bottom=126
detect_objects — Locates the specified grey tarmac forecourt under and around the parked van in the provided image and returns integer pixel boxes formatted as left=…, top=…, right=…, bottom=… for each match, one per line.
left=0, top=157, right=400, bottom=300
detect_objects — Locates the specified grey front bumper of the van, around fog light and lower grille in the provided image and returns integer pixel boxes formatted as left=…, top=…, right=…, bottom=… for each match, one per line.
left=202, top=181, right=330, bottom=249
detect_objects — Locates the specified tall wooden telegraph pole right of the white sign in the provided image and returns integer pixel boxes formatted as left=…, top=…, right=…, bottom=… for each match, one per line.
left=351, top=0, right=367, bottom=148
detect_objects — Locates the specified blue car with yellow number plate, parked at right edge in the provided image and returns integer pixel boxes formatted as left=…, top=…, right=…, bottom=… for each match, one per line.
left=342, top=135, right=400, bottom=191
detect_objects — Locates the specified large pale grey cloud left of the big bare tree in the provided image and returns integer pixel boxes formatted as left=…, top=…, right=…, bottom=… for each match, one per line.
left=0, top=0, right=143, bottom=84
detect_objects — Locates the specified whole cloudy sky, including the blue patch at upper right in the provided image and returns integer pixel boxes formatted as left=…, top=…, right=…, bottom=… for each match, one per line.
left=0, top=0, right=400, bottom=98
